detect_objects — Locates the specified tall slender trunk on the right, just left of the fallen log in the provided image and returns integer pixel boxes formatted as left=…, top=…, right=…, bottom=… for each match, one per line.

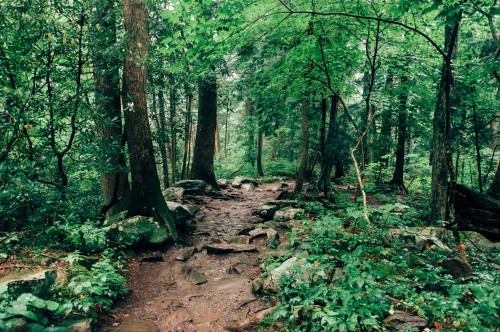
left=430, top=20, right=461, bottom=221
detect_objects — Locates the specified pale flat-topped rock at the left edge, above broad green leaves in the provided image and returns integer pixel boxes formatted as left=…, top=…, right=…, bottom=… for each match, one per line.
left=0, top=269, right=57, bottom=298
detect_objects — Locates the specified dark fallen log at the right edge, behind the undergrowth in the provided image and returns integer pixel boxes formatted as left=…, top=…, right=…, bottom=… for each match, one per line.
left=455, top=184, right=500, bottom=241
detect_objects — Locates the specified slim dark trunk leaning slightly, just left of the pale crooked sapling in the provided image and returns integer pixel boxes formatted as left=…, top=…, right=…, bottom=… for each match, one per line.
left=318, top=95, right=339, bottom=195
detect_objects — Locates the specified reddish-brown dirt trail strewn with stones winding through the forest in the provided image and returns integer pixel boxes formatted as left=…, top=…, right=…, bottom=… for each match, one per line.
left=100, top=183, right=284, bottom=332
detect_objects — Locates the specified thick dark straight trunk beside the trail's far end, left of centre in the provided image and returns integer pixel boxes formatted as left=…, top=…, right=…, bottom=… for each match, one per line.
left=191, top=75, right=219, bottom=190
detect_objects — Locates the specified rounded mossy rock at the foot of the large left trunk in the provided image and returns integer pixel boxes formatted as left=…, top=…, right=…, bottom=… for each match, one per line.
left=103, top=216, right=171, bottom=246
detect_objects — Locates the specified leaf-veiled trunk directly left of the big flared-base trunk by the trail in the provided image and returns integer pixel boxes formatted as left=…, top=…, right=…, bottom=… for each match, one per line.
left=94, top=6, right=130, bottom=217
